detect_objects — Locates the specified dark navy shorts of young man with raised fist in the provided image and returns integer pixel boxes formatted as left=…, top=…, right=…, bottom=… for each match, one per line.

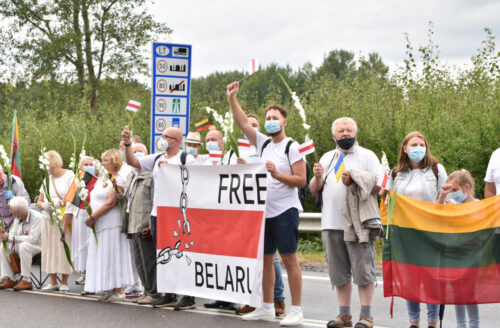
left=264, top=207, right=299, bottom=255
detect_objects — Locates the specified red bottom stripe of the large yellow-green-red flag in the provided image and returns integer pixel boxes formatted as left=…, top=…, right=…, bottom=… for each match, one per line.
left=382, top=261, right=500, bottom=304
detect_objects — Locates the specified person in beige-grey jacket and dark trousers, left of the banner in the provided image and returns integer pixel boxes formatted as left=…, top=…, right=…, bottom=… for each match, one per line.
left=118, top=143, right=160, bottom=305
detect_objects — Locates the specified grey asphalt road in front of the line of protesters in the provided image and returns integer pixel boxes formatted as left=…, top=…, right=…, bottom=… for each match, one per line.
left=0, top=271, right=500, bottom=328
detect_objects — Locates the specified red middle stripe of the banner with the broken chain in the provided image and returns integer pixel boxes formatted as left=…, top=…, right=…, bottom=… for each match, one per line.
left=157, top=206, right=264, bottom=258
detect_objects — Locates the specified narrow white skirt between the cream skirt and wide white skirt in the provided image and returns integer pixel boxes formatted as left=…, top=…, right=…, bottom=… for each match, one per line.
left=71, top=209, right=90, bottom=272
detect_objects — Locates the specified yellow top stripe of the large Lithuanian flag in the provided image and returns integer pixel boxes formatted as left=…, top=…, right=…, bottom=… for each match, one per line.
left=380, top=190, right=500, bottom=233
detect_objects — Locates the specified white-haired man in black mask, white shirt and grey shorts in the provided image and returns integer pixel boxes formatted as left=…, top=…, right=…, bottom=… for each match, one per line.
left=309, top=117, right=382, bottom=327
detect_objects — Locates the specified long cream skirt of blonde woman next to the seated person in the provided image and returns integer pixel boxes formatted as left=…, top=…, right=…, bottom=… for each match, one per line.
left=41, top=211, right=72, bottom=274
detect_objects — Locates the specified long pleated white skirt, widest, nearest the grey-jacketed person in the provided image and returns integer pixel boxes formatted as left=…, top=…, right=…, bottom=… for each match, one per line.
left=85, top=226, right=134, bottom=293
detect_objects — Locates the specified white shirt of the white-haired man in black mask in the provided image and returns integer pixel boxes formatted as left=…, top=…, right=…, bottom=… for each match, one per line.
left=319, top=144, right=382, bottom=230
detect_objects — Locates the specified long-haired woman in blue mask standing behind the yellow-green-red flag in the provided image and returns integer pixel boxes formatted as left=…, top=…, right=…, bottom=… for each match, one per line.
left=389, top=131, right=447, bottom=328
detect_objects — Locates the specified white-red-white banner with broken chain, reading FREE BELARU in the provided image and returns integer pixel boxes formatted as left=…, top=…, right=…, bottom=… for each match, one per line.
left=155, top=163, right=267, bottom=306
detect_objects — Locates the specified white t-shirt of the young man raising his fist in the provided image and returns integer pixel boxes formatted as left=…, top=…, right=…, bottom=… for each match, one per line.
left=257, top=132, right=304, bottom=218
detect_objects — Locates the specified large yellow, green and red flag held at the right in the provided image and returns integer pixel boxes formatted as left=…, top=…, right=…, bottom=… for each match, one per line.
left=381, top=191, right=500, bottom=304
